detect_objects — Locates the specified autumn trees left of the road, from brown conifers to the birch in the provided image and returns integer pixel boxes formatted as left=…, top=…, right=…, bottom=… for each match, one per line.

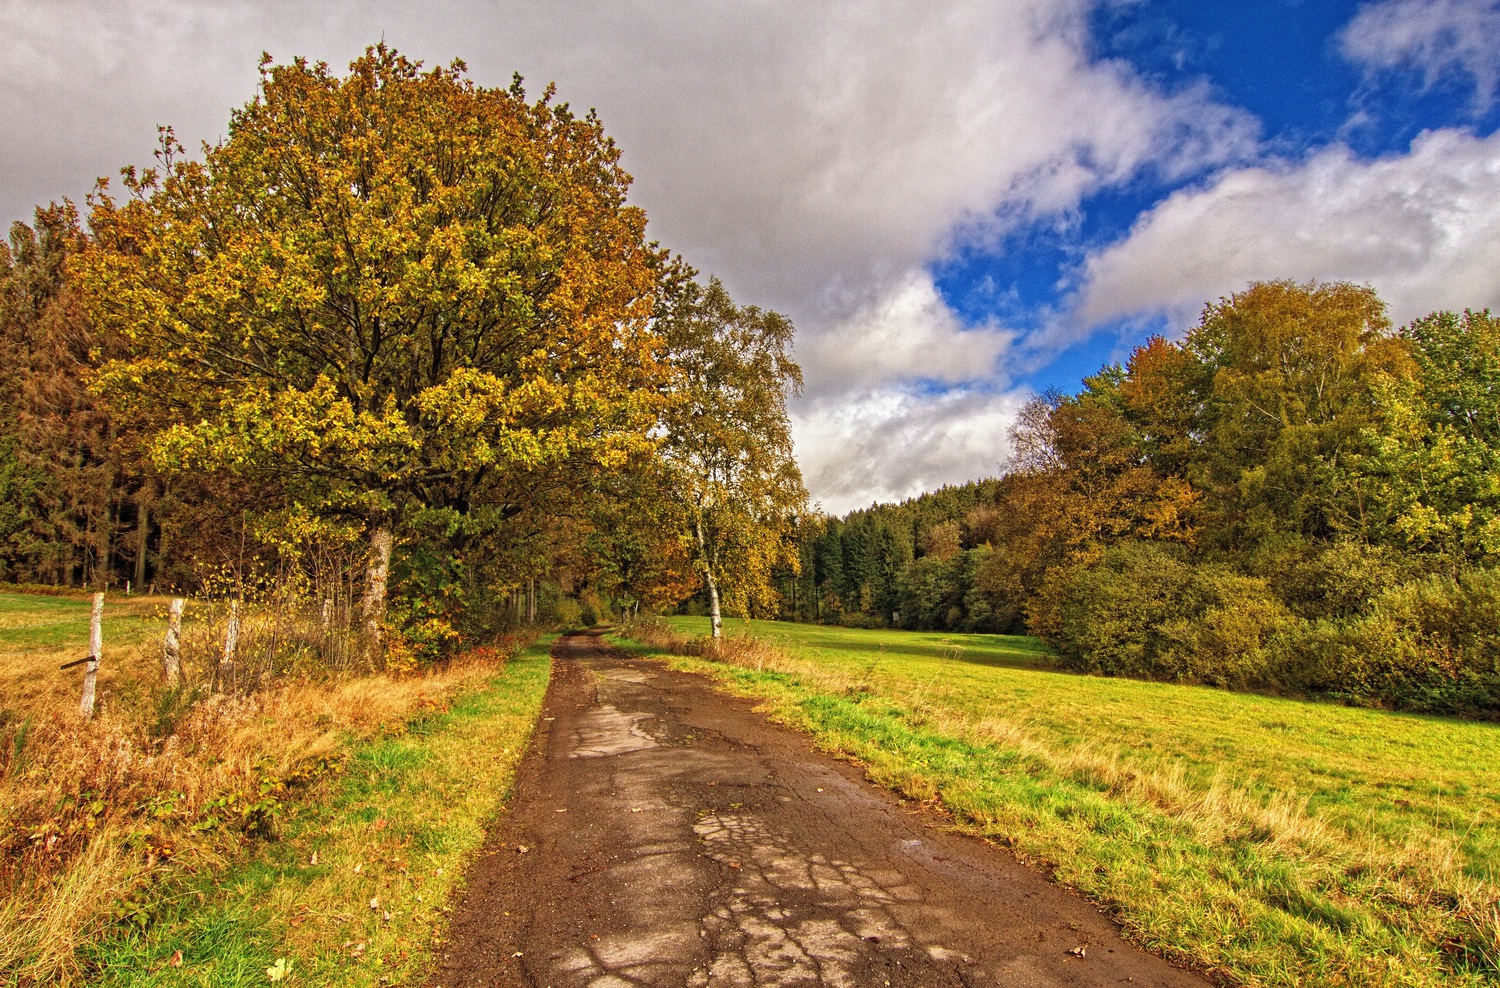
left=0, top=45, right=806, bottom=666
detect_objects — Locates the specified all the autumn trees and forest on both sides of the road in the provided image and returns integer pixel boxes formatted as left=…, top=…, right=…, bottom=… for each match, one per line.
left=0, top=48, right=1500, bottom=714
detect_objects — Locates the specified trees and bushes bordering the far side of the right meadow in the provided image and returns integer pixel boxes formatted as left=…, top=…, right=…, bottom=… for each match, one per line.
left=779, top=282, right=1500, bottom=715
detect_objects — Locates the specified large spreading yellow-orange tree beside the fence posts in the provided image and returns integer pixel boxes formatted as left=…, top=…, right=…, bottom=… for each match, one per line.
left=78, top=45, right=663, bottom=665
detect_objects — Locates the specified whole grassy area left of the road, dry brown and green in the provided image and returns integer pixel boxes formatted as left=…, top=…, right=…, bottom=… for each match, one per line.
left=0, top=594, right=549, bottom=985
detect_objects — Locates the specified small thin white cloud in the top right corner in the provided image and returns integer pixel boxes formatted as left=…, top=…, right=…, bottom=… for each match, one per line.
left=1340, top=0, right=1500, bottom=108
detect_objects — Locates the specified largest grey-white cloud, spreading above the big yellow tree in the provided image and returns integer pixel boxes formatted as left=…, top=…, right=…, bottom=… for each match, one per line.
left=0, top=0, right=1257, bottom=504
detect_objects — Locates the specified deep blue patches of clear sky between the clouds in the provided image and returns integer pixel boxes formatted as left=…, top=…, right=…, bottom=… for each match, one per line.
left=933, top=0, right=1500, bottom=391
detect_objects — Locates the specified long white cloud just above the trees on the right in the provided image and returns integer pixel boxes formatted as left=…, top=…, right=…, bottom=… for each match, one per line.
left=1077, top=129, right=1500, bottom=332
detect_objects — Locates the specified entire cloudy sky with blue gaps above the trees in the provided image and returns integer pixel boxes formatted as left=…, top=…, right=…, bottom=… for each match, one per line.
left=0, top=0, right=1500, bottom=514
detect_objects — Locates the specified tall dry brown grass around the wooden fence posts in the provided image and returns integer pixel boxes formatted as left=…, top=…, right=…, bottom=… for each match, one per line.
left=0, top=587, right=528, bottom=985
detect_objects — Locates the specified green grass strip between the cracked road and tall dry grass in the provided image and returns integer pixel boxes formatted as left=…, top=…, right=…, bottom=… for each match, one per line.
left=87, top=639, right=551, bottom=988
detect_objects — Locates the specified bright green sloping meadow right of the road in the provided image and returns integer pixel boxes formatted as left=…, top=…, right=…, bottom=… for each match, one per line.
left=624, top=618, right=1500, bottom=987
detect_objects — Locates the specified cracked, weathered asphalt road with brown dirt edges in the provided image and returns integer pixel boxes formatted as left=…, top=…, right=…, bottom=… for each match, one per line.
left=434, top=634, right=1206, bottom=988
